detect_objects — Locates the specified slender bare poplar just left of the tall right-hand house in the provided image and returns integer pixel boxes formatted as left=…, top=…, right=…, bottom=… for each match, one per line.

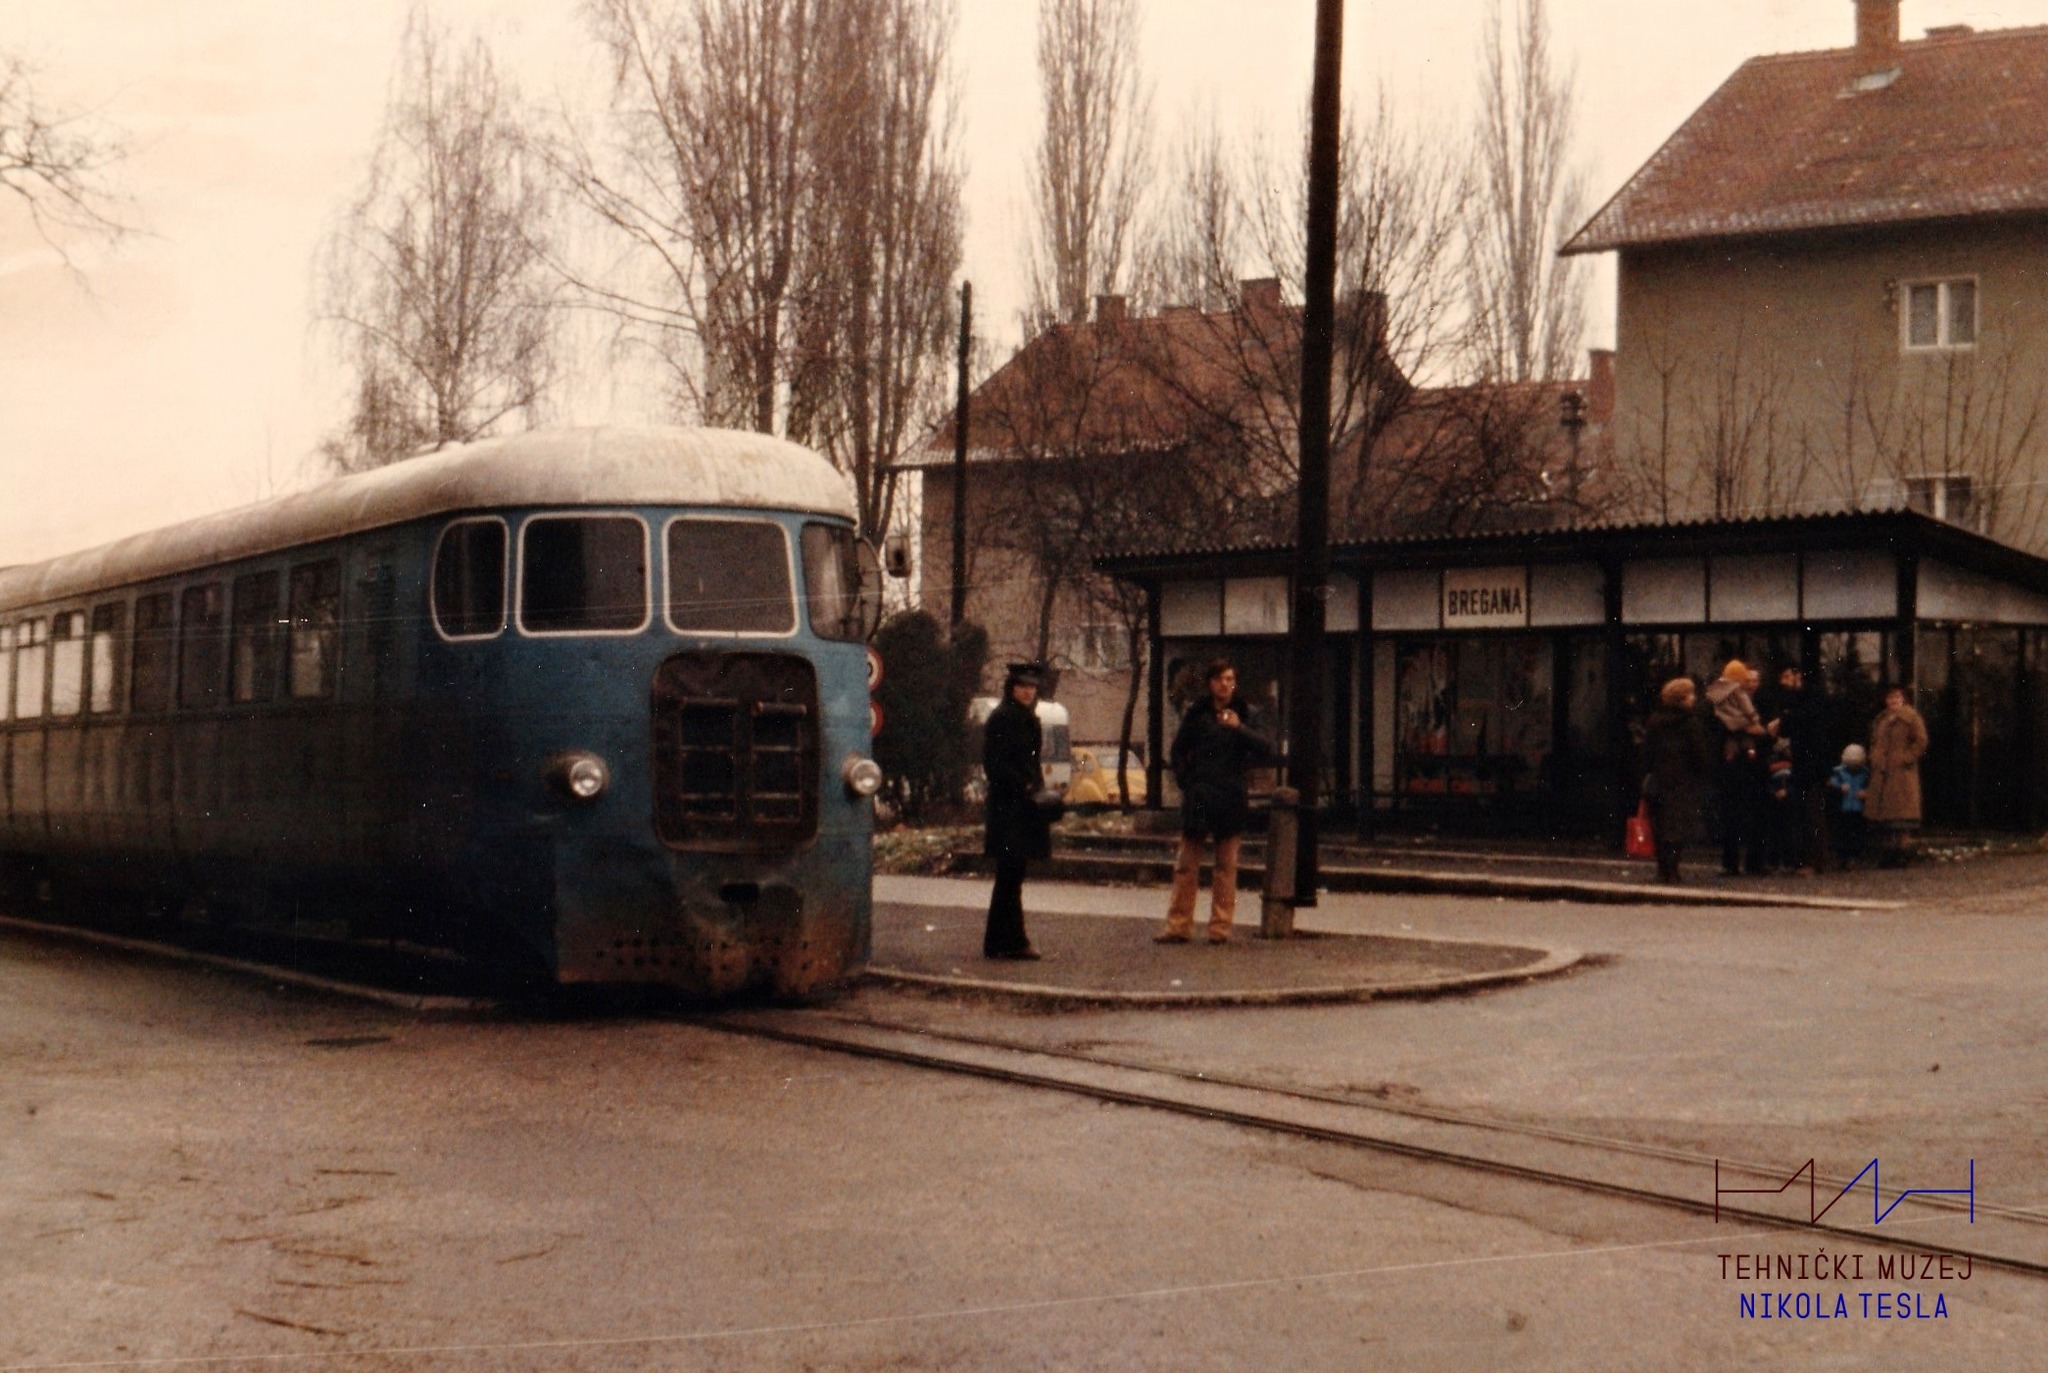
left=1466, top=0, right=1585, bottom=381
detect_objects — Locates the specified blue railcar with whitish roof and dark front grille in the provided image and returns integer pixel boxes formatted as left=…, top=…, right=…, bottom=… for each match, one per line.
left=0, top=428, right=881, bottom=994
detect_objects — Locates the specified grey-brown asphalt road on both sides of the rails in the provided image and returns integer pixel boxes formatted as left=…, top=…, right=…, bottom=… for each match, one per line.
left=0, top=865, right=2048, bottom=1373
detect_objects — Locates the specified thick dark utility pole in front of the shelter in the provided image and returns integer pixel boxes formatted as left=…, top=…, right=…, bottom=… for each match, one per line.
left=1286, top=0, right=1343, bottom=906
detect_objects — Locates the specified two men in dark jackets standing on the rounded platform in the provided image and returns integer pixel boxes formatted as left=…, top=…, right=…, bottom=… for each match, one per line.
left=981, top=658, right=1274, bottom=959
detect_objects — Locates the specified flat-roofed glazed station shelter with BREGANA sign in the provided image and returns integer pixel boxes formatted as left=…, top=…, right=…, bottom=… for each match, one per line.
left=1098, top=510, right=2048, bottom=836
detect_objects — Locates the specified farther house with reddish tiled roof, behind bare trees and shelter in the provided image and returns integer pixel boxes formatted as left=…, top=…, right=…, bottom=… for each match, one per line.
left=907, top=279, right=1614, bottom=740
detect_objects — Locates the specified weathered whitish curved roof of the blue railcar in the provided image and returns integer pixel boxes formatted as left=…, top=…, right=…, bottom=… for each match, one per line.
left=0, top=428, right=854, bottom=609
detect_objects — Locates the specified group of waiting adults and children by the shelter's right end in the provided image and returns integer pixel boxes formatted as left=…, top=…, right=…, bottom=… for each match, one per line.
left=1642, top=660, right=1927, bottom=881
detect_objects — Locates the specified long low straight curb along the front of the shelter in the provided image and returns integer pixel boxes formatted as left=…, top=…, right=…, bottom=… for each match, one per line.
left=954, top=855, right=1907, bottom=910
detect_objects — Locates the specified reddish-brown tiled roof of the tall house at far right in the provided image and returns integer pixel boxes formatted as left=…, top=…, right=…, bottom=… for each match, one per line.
left=1563, top=27, right=2048, bottom=254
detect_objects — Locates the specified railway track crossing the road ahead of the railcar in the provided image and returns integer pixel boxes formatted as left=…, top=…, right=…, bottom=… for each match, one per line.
left=690, top=1010, right=2048, bottom=1277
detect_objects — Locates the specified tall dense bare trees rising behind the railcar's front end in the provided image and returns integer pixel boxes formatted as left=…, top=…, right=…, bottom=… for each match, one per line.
left=551, top=0, right=961, bottom=537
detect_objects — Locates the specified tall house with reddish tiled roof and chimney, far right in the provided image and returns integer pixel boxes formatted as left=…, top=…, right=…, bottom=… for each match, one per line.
left=1563, top=0, right=2048, bottom=545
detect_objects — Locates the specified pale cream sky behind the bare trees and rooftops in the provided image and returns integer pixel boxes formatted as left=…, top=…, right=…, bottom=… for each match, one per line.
left=0, top=0, right=2048, bottom=564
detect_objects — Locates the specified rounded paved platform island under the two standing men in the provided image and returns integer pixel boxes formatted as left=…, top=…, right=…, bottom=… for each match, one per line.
left=868, top=883, right=1581, bottom=1006
